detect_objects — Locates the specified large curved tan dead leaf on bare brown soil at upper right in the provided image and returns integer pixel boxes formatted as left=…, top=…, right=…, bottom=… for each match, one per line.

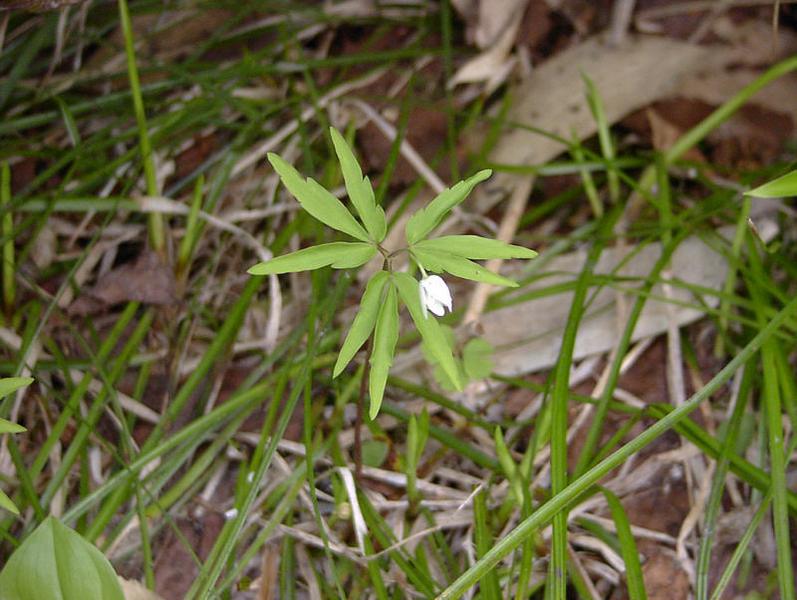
left=474, top=36, right=709, bottom=214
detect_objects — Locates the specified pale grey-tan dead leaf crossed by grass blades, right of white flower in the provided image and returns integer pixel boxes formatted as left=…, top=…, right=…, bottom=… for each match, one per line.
left=395, top=219, right=772, bottom=381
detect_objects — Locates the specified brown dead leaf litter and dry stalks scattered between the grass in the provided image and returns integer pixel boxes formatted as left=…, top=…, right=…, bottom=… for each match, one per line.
left=1, top=2, right=794, bottom=599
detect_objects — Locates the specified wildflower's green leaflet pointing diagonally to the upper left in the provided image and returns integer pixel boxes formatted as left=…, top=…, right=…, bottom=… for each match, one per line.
left=268, top=152, right=368, bottom=242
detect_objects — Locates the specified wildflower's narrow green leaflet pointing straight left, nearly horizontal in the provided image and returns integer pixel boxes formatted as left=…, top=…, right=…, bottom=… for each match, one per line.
left=247, top=242, right=376, bottom=275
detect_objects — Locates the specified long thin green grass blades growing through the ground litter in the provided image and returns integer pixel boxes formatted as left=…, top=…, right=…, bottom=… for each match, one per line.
left=0, top=0, right=797, bottom=600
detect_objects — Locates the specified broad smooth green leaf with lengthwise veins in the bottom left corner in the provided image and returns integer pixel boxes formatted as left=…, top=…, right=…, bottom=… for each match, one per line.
left=0, top=517, right=124, bottom=600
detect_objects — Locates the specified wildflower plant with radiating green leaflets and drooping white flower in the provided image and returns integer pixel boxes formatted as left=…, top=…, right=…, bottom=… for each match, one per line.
left=248, top=128, right=537, bottom=419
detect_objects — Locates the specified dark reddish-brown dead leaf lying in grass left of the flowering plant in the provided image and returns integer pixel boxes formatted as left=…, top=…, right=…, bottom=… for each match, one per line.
left=69, top=250, right=177, bottom=315
